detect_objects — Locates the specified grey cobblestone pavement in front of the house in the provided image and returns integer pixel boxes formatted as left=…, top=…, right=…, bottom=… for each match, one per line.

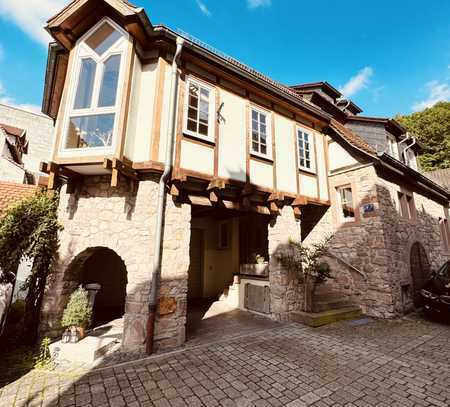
left=0, top=317, right=450, bottom=407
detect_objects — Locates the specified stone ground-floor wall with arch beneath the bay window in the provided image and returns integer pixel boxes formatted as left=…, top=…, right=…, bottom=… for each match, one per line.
left=40, top=177, right=191, bottom=350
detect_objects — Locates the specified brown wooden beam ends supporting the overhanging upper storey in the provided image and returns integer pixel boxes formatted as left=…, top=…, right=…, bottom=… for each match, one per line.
left=40, top=158, right=330, bottom=218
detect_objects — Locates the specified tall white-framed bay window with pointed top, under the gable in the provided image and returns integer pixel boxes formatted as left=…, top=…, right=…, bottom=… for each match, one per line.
left=62, top=19, right=128, bottom=153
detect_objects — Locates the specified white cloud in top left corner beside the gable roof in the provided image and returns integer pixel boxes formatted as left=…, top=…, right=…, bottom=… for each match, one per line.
left=0, top=0, right=68, bottom=45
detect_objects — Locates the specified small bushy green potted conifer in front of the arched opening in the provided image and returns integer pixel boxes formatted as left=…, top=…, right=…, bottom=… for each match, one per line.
left=61, top=286, right=92, bottom=342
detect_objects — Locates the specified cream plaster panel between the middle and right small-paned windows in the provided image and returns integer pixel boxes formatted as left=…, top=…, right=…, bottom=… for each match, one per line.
left=272, top=114, right=297, bottom=193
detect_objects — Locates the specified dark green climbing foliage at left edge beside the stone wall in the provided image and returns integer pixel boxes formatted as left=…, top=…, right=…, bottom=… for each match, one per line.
left=0, top=191, right=60, bottom=340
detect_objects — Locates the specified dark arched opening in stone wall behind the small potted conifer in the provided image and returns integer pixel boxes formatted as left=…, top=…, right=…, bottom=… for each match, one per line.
left=65, top=247, right=127, bottom=327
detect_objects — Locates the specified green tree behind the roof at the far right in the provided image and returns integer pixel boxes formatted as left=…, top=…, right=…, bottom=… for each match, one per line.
left=395, top=102, right=450, bottom=171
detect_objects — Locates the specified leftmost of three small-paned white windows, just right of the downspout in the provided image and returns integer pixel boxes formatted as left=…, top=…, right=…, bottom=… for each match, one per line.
left=184, top=78, right=215, bottom=141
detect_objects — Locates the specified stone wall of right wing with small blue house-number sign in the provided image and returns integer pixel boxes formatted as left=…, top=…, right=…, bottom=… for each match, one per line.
left=304, top=165, right=448, bottom=318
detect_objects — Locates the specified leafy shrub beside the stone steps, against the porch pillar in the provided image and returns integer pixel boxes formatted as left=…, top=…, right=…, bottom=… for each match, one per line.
left=276, top=236, right=332, bottom=312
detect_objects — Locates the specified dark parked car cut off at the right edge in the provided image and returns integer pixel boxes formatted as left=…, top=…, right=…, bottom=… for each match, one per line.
left=420, top=261, right=450, bottom=322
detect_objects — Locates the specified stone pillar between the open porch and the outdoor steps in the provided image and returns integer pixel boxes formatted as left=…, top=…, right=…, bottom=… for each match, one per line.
left=268, top=206, right=303, bottom=321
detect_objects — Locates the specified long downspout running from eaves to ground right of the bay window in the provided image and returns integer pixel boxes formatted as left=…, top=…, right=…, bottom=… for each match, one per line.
left=145, top=37, right=184, bottom=355
